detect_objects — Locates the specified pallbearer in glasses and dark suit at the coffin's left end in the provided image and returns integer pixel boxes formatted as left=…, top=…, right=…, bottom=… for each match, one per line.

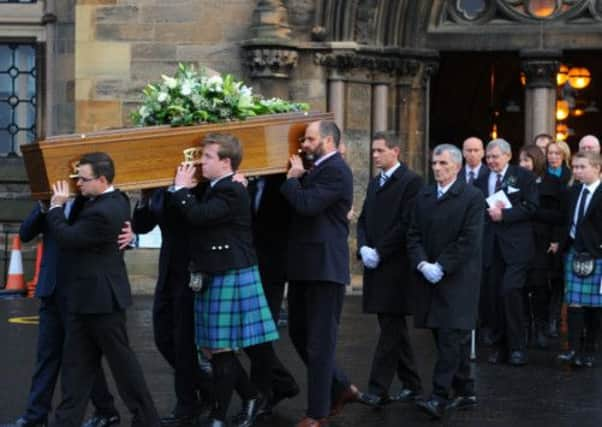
left=48, top=153, right=160, bottom=427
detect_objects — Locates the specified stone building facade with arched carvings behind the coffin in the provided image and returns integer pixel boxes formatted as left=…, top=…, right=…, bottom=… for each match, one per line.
left=0, top=0, right=602, bottom=277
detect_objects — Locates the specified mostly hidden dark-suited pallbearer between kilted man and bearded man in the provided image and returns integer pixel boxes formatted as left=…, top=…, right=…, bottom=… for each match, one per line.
left=247, top=175, right=299, bottom=411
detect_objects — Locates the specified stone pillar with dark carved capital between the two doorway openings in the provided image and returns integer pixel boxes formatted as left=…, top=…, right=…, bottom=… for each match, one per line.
left=520, top=50, right=562, bottom=144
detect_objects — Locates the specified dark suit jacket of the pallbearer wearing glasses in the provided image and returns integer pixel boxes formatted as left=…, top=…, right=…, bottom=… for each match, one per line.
left=47, top=190, right=132, bottom=314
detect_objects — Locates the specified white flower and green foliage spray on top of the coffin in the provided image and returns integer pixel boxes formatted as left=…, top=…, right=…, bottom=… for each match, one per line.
left=131, top=64, right=309, bottom=126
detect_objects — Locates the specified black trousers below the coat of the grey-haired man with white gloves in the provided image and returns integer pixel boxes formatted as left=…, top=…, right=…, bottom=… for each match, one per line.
left=433, top=328, right=475, bottom=399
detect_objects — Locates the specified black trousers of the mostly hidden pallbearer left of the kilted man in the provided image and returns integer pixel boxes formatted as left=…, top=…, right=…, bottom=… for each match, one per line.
left=153, top=272, right=212, bottom=416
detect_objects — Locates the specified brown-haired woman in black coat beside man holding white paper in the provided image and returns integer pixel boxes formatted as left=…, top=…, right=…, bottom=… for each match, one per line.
left=520, top=145, right=563, bottom=348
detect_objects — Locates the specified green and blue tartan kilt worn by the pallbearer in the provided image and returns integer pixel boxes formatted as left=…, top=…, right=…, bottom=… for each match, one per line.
left=194, top=265, right=278, bottom=349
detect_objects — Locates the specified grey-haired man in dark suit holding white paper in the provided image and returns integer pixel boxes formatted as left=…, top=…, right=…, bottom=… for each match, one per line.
left=476, top=139, right=539, bottom=366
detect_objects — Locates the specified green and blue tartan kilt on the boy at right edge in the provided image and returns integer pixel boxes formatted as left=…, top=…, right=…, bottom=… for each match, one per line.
left=564, top=248, right=602, bottom=307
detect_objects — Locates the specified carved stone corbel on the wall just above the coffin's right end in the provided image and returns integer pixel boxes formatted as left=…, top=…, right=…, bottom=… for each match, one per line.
left=243, top=47, right=299, bottom=78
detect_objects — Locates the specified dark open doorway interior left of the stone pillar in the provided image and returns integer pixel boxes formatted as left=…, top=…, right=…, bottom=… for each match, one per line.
left=430, top=52, right=524, bottom=155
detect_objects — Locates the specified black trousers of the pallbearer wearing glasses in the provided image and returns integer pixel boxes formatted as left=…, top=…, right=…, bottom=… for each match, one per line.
left=52, top=311, right=160, bottom=427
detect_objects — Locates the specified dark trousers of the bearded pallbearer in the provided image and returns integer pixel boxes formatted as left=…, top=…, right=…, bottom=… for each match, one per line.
left=288, top=281, right=350, bottom=419
